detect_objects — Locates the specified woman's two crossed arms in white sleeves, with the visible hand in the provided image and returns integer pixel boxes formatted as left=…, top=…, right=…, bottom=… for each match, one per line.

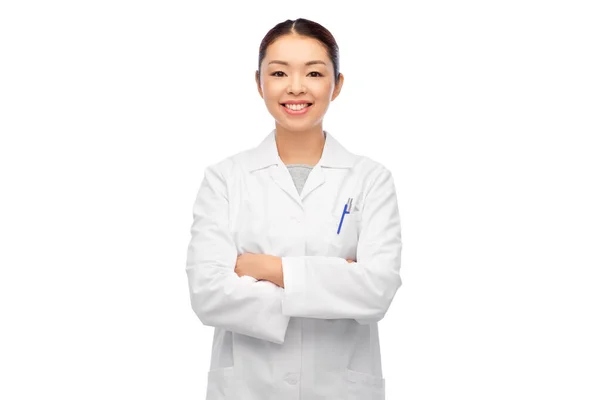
left=186, top=165, right=402, bottom=343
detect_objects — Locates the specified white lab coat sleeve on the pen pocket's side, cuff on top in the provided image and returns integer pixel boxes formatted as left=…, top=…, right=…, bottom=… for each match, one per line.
left=282, top=167, right=402, bottom=324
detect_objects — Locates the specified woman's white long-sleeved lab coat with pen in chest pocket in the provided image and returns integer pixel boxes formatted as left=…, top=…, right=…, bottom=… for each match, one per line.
left=186, top=130, right=402, bottom=400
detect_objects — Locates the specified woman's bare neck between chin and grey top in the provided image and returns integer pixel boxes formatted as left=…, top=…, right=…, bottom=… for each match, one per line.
left=275, top=124, right=325, bottom=166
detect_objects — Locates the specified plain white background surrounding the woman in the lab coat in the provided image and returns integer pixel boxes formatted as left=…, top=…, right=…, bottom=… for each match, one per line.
left=0, top=0, right=600, bottom=400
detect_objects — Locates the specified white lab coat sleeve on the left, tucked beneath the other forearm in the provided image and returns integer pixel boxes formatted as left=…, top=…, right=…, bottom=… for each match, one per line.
left=186, top=165, right=290, bottom=344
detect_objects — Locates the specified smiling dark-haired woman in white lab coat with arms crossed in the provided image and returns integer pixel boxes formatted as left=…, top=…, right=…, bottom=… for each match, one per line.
left=187, top=19, right=402, bottom=400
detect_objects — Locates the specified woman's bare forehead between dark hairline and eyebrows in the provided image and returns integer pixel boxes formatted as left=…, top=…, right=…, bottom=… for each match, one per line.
left=263, top=35, right=331, bottom=66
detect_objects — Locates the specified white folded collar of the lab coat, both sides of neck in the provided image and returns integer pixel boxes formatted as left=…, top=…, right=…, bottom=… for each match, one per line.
left=246, top=129, right=357, bottom=171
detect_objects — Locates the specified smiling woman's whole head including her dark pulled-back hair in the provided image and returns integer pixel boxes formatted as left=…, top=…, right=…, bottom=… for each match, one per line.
left=256, top=19, right=344, bottom=136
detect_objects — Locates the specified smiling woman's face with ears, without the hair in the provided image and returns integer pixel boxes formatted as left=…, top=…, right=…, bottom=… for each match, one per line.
left=256, top=35, right=344, bottom=131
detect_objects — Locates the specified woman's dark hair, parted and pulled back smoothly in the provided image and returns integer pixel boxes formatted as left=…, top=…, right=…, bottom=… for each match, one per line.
left=256, top=18, right=340, bottom=85
